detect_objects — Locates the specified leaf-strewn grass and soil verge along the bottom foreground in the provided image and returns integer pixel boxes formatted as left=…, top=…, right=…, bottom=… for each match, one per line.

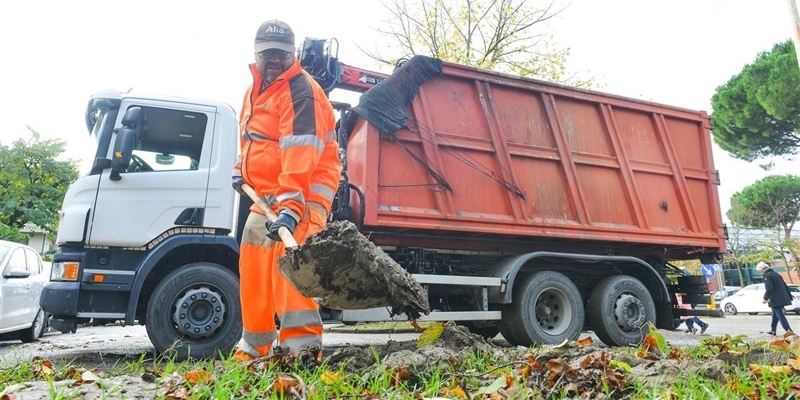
left=0, top=323, right=800, bottom=400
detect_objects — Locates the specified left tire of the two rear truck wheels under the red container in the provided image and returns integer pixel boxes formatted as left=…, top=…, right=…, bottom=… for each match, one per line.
left=500, top=271, right=584, bottom=347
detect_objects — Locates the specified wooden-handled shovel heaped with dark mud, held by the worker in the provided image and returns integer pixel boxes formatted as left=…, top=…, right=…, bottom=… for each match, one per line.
left=242, top=184, right=430, bottom=319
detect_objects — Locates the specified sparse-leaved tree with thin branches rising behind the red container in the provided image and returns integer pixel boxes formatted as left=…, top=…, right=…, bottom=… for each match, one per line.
left=361, top=0, right=594, bottom=87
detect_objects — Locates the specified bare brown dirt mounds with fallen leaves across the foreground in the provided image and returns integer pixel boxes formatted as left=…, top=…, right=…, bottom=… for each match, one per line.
left=0, top=322, right=798, bottom=400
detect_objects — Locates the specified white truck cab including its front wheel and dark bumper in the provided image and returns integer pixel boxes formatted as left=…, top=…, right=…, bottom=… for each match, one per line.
left=41, top=92, right=241, bottom=357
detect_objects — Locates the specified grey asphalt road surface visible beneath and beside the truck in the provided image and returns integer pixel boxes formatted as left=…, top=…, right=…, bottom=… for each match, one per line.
left=0, top=314, right=800, bottom=367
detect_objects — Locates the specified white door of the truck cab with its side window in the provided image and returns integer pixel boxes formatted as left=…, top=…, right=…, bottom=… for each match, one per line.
left=88, top=101, right=216, bottom=247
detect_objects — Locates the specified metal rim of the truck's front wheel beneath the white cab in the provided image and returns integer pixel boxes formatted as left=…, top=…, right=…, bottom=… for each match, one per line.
left=172, top=286, right=225, bottom=338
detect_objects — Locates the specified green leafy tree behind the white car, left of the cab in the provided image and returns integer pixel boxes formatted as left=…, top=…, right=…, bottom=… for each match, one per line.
left=0, top=127, right=78, bottom=241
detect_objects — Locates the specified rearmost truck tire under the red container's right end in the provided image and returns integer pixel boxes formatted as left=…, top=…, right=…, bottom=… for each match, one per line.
left=588, top=275, right=656, bottom=346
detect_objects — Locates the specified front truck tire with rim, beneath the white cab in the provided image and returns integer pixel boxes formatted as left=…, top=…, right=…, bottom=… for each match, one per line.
left=145, top=262, right=242, bottom=360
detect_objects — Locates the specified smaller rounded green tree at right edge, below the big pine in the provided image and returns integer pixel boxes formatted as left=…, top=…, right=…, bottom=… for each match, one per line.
left=727, top=175, right=800, bottom=239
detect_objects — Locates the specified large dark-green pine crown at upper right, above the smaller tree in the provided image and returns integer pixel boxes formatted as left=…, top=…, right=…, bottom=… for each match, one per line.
left=711, top=40, right=800, bottom=161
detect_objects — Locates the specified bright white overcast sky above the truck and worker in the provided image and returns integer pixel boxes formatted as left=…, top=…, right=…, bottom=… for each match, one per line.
left=0, top=0, right=800, bottom=219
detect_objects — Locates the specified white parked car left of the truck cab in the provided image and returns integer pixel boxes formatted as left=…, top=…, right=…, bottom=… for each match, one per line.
left=0, top=240, right=50, bottom=343
